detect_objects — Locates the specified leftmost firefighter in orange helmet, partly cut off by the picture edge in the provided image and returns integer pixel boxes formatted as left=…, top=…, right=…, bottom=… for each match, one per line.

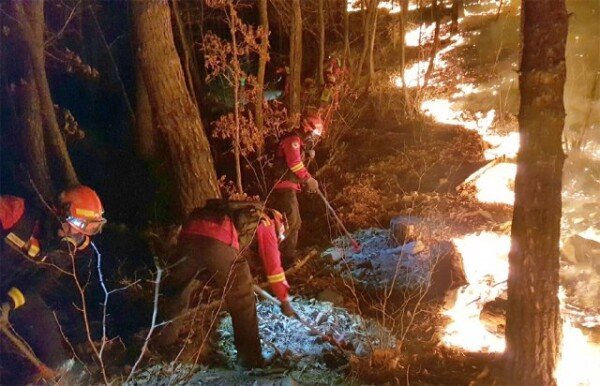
left=0, top=186, right=106, bottom=384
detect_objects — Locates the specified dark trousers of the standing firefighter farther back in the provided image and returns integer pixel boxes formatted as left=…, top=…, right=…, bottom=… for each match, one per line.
left=269, top=189, right=302, bottom=269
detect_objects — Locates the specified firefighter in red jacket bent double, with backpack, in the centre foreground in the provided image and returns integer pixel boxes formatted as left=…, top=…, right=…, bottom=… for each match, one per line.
left=157, top=199, right=295, bottom=368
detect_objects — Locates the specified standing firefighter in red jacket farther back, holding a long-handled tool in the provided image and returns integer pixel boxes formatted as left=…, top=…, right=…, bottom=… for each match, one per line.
left=269, top=110, right=323, bottom=269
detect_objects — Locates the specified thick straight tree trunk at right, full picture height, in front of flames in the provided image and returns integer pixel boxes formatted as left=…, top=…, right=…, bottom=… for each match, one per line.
left=505, top=0, right=567, bottom=386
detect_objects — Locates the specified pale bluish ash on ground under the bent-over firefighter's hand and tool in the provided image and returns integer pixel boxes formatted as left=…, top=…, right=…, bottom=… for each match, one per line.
left=218, top=298, right=396, bottom=371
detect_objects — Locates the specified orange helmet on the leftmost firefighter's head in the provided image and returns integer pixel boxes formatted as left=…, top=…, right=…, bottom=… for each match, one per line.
left=58, top=185, right=106, bottom=236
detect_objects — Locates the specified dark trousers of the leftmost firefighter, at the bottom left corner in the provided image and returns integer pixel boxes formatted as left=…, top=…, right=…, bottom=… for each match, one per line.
left=0, top=294, right=71, bottom=384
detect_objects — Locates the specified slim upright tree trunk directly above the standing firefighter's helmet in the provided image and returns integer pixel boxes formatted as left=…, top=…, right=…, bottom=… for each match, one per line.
left=289, top=0, right=302, bottom=121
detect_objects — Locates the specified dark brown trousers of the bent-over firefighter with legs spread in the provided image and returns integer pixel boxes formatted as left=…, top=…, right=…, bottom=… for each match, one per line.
left=158, top=236, right=262, bottom=367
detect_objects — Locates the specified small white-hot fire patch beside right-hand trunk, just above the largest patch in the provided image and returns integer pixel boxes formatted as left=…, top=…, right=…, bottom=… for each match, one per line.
left=475, top=162, right=517, bottom=205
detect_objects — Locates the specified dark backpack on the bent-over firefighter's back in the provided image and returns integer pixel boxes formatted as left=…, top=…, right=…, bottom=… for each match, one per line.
left=204, top=199, right=264, bottom=250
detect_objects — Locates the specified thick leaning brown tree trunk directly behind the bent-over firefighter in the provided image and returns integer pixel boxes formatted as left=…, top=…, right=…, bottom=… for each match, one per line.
left=132, top=1, right=220, bottom=215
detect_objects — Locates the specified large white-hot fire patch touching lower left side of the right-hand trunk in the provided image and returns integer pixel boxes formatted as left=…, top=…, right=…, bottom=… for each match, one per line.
left=442, top=232, right=510, bottom=352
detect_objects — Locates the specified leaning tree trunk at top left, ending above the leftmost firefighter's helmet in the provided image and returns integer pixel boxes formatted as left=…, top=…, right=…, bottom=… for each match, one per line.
left=12, top=0, right=79, bottom=189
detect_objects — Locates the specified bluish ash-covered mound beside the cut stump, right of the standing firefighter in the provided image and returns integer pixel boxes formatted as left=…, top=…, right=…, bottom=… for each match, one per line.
left=322, top=228, right=432, bottom=288
